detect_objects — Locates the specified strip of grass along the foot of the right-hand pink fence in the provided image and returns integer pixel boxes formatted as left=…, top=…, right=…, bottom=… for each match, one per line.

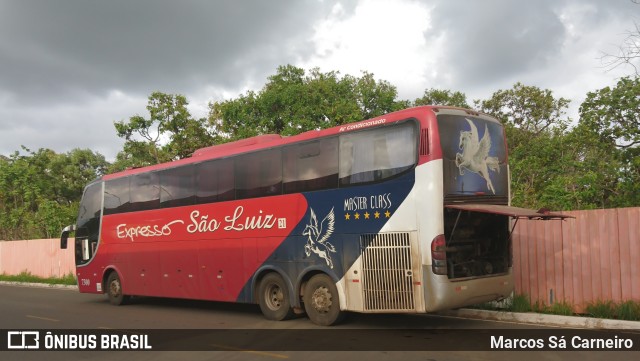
left=472, top=294, right=640, bottom=321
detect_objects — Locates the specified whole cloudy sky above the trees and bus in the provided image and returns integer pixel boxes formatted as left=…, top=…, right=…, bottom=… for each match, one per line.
left=0, top=0, right=640, bottom=160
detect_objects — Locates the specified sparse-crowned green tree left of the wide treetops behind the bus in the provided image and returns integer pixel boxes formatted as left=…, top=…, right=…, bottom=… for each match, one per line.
left=111, top=92, right=215, bottom=170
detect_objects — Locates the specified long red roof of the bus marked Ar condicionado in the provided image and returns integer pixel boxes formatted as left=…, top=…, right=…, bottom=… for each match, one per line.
left=102, top=105, right=490, bottom=180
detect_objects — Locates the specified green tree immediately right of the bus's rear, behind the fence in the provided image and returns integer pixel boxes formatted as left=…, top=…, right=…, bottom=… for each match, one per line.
left=475, top=83, right=574, bottom=209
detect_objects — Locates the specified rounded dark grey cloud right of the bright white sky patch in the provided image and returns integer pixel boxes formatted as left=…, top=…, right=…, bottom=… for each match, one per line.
left=433, top=0, right=564, bottom=83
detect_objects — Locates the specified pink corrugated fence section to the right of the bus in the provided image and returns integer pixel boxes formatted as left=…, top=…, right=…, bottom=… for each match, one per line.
left=513, top=208, right=640, bottom=312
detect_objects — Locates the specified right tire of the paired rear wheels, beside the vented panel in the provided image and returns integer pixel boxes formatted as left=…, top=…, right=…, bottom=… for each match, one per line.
left=303, top=274, right=345, bottom=326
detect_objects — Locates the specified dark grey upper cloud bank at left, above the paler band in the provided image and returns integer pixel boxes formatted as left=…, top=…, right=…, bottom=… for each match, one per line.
left=0, top=1, right=330, bottom=102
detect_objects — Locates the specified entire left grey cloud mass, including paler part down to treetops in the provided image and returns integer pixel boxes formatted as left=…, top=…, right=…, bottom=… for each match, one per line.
left=0, top=0, right=331, bottom=157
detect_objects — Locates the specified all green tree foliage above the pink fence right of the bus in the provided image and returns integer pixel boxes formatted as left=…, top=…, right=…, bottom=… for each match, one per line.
left=476, top=78, right=640, bottom=210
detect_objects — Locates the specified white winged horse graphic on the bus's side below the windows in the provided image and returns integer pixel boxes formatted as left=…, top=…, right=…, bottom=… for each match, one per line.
left=302, top=208, right=336, bottom=268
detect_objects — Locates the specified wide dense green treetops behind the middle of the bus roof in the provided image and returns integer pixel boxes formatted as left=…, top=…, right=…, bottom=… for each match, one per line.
left=209, top=65, right=408, bottom=140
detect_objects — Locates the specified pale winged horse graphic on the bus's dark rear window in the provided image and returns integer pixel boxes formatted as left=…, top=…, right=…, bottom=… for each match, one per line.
left=456, top=118, right=500, bottom=194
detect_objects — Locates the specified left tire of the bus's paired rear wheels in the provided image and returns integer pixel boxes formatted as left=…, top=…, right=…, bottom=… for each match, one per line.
left=258, top=273, right=293, bottom=321
